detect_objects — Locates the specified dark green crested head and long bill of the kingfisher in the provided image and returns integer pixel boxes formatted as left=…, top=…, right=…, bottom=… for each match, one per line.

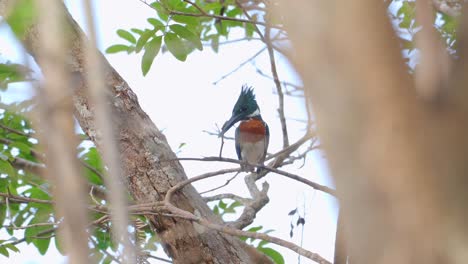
left=221, top=85, right=260, bottom=135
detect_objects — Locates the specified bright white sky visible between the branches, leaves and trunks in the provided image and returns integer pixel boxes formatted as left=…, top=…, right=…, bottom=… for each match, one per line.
left=0, top=0, right=336, bottom=264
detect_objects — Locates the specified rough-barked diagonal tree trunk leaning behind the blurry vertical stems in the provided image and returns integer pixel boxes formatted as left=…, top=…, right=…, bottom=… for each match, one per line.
left=0, top=0, right=271, bottom=264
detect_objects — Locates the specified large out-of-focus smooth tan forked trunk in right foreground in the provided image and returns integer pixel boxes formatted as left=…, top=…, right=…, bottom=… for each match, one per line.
left=278, top=0, right=468, bottom=264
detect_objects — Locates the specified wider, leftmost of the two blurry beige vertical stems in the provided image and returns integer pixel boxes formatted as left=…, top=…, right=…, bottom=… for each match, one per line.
left=37, top=0, right=89, bottom=264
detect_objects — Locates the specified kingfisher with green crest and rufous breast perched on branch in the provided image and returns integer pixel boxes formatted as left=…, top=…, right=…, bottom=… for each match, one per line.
left=221, top=85, right=270, bottom=173
